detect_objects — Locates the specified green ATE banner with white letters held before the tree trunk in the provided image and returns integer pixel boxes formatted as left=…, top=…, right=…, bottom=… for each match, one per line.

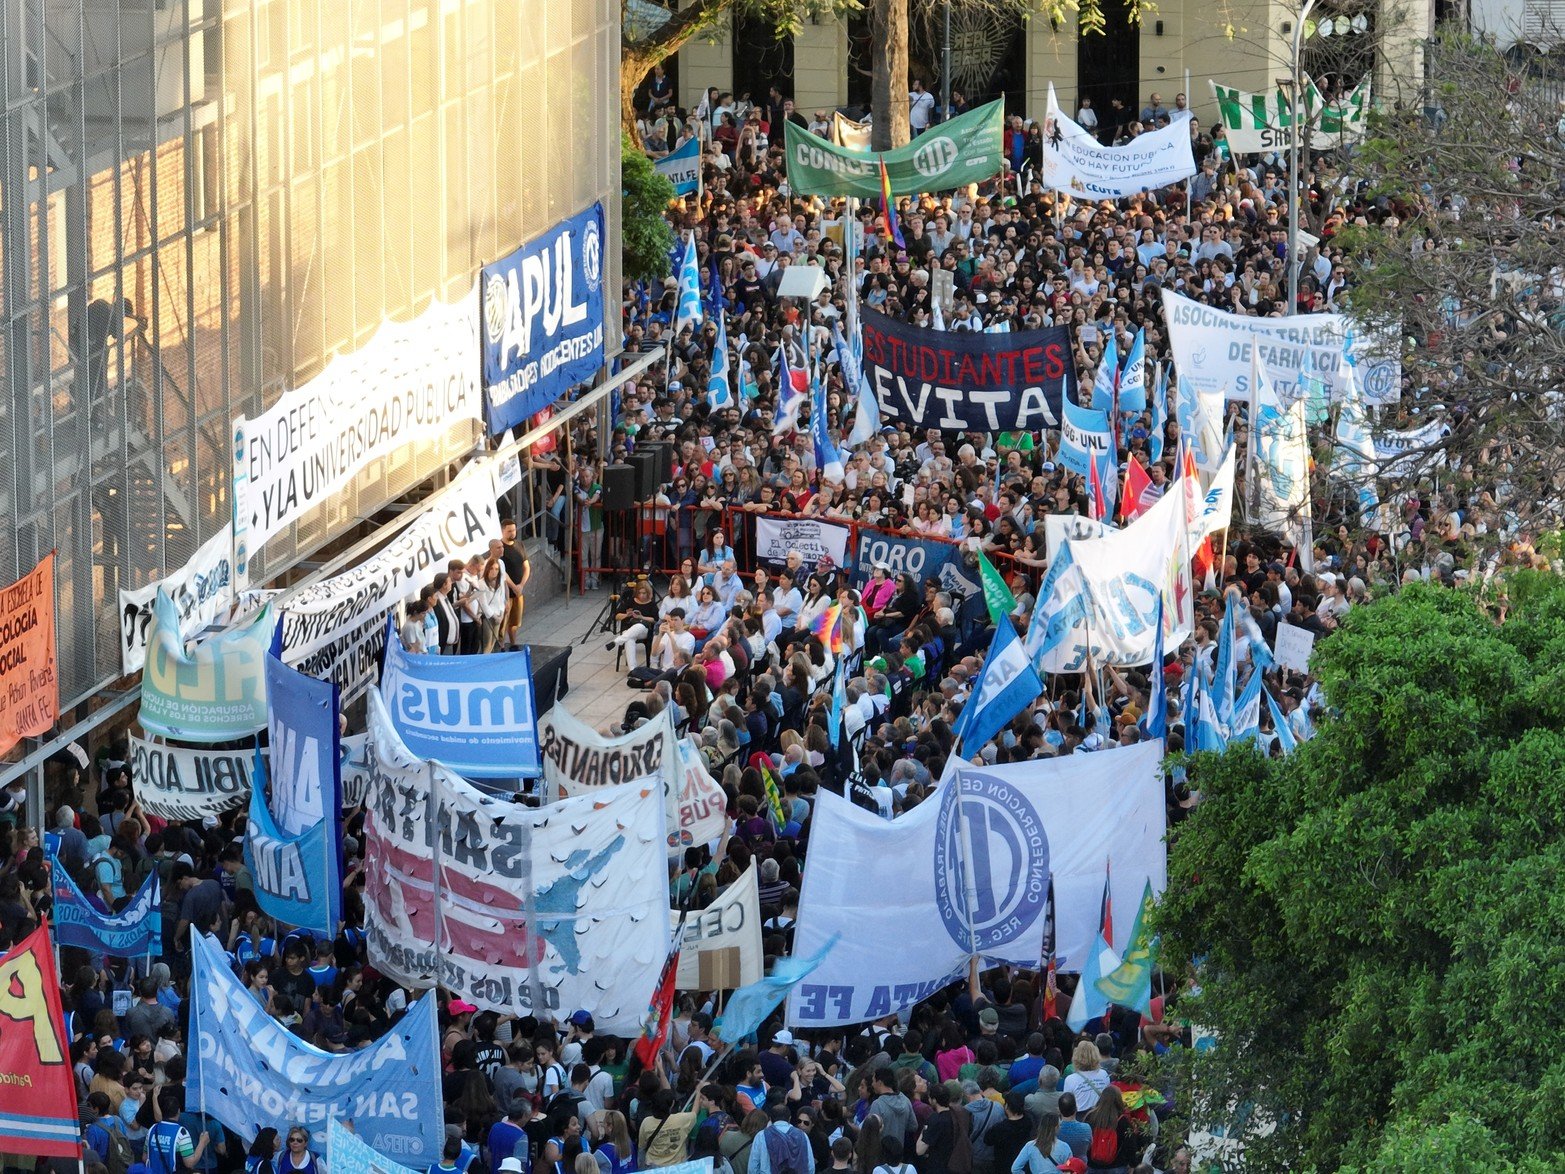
left=783, top=102, right=1005, bottom=199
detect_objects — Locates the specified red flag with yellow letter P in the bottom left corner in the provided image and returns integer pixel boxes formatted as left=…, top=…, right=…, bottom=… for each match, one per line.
left=0, top=924, right=81, bottom=1158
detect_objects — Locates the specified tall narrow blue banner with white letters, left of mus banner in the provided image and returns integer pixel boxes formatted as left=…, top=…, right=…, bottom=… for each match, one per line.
left=244, top=653, right=343, bottom=938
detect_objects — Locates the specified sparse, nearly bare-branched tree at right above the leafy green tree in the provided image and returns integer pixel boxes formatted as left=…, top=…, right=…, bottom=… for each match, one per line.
left=1338, top=31, right=1565, bottom=529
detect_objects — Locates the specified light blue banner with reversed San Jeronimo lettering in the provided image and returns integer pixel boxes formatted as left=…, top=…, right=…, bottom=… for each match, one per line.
left=185, top=935, right=446, bottom=1169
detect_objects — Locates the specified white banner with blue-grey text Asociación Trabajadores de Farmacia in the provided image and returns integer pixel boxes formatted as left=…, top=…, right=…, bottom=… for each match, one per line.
left=1163, top=290, right=1402, bottom=406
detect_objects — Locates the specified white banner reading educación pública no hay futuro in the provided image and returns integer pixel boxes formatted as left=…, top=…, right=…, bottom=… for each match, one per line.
left=1039, top=81, right=1196, bottom=200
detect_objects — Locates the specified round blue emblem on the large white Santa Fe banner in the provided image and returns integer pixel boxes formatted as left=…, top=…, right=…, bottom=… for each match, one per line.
left=934, top=770, right=1049, bottom=955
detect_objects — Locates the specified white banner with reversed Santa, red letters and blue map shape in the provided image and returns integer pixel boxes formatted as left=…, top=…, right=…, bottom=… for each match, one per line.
left=365, top=689, right=670, bottom=1036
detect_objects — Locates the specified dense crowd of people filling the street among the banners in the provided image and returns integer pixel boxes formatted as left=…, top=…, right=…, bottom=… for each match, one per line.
left=0, top=62, right=1539, bottom=1174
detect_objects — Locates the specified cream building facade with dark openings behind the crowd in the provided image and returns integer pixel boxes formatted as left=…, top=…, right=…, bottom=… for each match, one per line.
left=678, top=0, right=1434, bottom=132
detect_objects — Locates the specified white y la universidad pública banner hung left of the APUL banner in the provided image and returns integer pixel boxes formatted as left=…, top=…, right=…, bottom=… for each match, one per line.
left=233, top=288, right=484, bottom=581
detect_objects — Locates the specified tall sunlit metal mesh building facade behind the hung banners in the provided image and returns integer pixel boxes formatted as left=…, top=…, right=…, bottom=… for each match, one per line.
left=0, top=0, right=620, bottom=706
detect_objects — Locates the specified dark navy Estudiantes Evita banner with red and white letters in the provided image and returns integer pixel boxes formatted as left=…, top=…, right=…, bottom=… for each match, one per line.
left=861, top=308, right=1075, bottom=432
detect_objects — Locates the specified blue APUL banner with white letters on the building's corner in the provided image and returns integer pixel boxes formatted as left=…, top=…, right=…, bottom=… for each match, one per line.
left=482, top=203, right=604, bottom=434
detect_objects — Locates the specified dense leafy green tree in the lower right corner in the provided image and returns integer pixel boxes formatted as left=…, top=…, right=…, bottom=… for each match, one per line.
left=1157, top=573, right=1565, bottom=1172
